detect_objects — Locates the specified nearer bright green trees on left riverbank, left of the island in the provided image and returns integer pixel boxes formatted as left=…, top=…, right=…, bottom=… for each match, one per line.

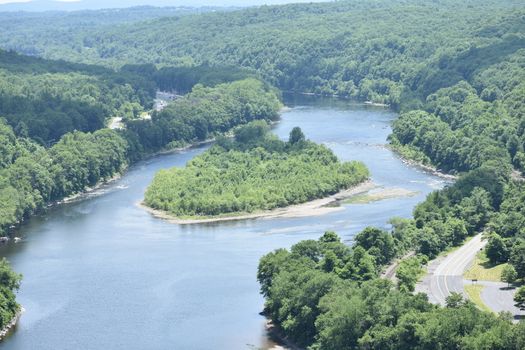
left=0, top=123, right=128, bottom=232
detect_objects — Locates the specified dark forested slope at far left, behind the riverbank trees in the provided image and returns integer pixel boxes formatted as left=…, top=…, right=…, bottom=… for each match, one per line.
left=0, top=50, right=156, bottom=146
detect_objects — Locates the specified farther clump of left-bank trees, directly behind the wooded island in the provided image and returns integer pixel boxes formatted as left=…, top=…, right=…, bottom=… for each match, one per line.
left=126, top=78, right=281, bottom=159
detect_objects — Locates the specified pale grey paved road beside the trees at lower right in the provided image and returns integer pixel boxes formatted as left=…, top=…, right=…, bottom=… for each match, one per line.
left=416, top=234, right=486, bottom=305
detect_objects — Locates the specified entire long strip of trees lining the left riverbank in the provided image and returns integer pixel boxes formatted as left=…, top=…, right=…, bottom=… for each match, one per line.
left=0, top=74, right=280, bottom=233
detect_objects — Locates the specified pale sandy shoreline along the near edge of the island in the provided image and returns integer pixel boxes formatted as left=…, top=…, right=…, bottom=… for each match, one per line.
left=137, top=180, right=376, bottom=225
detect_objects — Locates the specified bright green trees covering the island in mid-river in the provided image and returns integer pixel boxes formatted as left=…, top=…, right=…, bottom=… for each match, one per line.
left=144, top=121, right=369, bottom=218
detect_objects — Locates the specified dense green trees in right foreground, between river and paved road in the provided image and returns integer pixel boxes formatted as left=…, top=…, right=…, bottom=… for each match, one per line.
left=257, top=231, right=525, bottom=350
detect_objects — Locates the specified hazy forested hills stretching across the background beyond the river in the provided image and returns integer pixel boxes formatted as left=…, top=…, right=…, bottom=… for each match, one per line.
left=0, top=0, right=523, bottom=106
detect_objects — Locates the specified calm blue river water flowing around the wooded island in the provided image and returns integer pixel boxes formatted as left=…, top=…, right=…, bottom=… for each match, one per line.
left=0, top=98, right=444, bottom=350
